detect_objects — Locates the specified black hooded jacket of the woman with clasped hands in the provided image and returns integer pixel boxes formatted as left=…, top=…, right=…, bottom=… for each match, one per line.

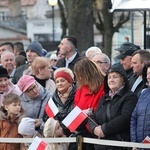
left=89, top=65, right=137, bottom=150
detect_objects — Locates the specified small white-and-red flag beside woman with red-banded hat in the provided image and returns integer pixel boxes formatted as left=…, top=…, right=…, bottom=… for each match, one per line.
left=45, top=98, right=59, bottom=118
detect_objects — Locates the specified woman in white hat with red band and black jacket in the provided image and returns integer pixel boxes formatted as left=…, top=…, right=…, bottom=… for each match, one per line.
left=44, top=67, right=76, bottom=136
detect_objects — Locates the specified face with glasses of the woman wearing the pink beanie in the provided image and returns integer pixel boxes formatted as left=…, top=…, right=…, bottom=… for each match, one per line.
left=25, top=82, right=40, bottom=98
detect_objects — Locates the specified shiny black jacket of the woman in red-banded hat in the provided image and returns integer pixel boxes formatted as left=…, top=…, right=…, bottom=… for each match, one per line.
left=43, top=85, right=76, bottom=136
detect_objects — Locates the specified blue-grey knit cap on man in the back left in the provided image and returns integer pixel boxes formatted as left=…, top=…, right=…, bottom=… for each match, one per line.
left=26, top=41, right=43, bottom=56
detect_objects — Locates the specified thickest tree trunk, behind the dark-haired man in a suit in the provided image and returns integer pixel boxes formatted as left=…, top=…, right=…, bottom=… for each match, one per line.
left=67, top=0, right=94, bottom=53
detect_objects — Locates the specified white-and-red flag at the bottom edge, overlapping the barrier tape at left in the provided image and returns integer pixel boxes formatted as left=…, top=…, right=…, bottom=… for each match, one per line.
left=28, top=136, right=48, bottom=150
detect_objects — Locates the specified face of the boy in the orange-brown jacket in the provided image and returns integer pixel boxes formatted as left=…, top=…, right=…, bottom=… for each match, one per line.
left=5, top=101, right=21, bottom=115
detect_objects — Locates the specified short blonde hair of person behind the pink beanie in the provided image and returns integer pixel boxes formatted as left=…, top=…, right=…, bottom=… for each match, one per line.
left=31, top=57, right=50, bottom=75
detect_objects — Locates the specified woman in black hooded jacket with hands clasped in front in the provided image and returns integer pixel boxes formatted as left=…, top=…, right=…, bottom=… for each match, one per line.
left=89, top=64, right=138, bottom=150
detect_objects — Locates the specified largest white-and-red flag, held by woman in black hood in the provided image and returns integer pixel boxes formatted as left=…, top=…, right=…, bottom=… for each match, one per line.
left=62, top=106, right=87, bottom=132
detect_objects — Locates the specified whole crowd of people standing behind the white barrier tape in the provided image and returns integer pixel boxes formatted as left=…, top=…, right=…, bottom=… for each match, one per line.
left=0, top=36, right=150, bottom=150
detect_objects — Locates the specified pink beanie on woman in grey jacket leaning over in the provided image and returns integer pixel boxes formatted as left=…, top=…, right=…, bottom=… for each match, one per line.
left=17, top=75, right=35, bottom=92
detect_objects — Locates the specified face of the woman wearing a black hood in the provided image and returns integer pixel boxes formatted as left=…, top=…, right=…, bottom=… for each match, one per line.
left=107, top=72, right=124, bottom=92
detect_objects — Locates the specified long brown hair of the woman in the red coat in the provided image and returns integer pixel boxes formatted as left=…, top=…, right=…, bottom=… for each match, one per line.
left=74, top=58, right=104, bottom=94
